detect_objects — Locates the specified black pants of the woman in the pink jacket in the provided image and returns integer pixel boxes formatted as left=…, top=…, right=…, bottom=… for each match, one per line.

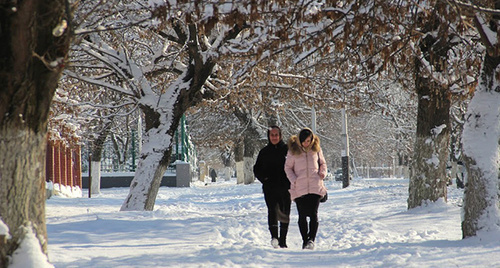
left=295, top=194, right=321, bottom=243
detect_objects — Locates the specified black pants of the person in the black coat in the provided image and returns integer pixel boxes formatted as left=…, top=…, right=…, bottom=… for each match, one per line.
left=264, top=190, right=292, bottom=239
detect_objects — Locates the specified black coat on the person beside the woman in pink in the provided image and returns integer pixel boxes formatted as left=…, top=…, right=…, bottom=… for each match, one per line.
left=253, top=141, right=290, bottom=193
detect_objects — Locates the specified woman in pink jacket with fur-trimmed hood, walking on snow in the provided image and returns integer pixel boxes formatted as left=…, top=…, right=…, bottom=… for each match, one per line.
left=285, top=128, right=327, bottom=249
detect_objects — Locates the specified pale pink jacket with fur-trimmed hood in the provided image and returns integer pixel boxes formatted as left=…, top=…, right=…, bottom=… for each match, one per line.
left=285, top=135, right=327, bottom=200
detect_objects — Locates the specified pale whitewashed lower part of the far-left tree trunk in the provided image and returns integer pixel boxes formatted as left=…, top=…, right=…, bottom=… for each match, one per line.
left=0, top=128, right=47, bottom=267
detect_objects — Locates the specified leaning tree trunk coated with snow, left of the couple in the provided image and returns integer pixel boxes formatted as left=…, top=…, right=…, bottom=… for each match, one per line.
left=120, top=47, right=215, bottom=211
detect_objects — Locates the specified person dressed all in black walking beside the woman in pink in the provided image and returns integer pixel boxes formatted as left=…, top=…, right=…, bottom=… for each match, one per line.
left=253, top=126, right=292, bottom=248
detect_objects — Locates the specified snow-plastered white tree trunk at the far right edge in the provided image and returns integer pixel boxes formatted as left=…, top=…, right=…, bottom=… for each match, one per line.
left=462, top=54, right=500, bottom=238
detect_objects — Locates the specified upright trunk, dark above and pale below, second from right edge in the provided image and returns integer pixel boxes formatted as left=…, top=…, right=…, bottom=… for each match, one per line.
left=408, top=6, right=451, bottom=209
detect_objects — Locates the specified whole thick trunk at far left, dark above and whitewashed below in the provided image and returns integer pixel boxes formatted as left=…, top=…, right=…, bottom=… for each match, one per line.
left=0, top=0, right=71, bottom=267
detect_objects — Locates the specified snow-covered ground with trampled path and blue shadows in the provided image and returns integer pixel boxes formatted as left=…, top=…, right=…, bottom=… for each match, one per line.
left=46, top=178, right=500, bottom=268
